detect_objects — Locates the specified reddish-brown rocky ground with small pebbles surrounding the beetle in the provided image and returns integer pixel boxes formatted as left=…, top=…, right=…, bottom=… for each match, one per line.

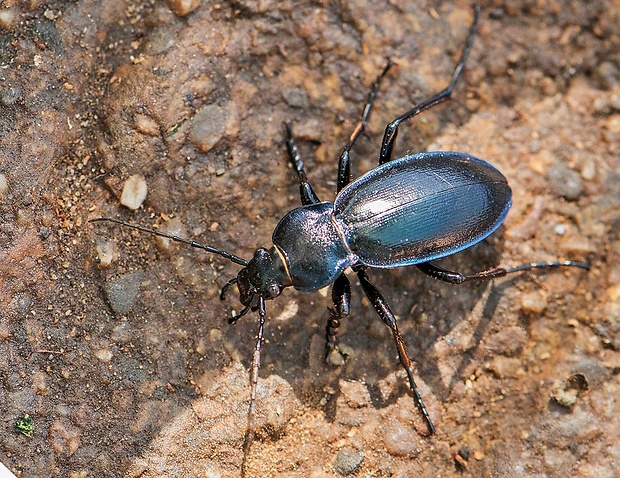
left=0, top=0, right=620, bottom=478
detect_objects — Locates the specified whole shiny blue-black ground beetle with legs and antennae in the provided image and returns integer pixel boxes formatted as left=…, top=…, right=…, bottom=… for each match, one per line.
left=93, top=7, right=589, bottom=450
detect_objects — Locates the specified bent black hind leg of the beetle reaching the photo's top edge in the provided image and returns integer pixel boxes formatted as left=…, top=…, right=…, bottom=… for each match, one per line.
left=379, top=6, right=480, bottom=164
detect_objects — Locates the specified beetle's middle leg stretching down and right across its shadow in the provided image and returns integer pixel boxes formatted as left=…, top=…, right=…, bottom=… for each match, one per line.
left=354, top=269, right=435, bottom=435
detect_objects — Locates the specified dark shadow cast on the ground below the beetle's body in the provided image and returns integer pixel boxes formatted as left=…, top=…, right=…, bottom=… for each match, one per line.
left=234, top=229, right=519, bottom=432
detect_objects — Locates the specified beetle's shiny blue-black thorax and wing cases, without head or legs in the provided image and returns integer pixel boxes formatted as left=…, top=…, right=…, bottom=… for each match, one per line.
left=270, top=152, right=511, bottom=291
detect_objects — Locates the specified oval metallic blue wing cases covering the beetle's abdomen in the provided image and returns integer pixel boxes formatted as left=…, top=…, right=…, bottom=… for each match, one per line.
left=334, top=152, right=511, bottom=268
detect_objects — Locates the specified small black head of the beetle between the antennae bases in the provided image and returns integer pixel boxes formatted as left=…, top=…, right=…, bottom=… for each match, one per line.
left=237, top=247, right=292, bottom=307
